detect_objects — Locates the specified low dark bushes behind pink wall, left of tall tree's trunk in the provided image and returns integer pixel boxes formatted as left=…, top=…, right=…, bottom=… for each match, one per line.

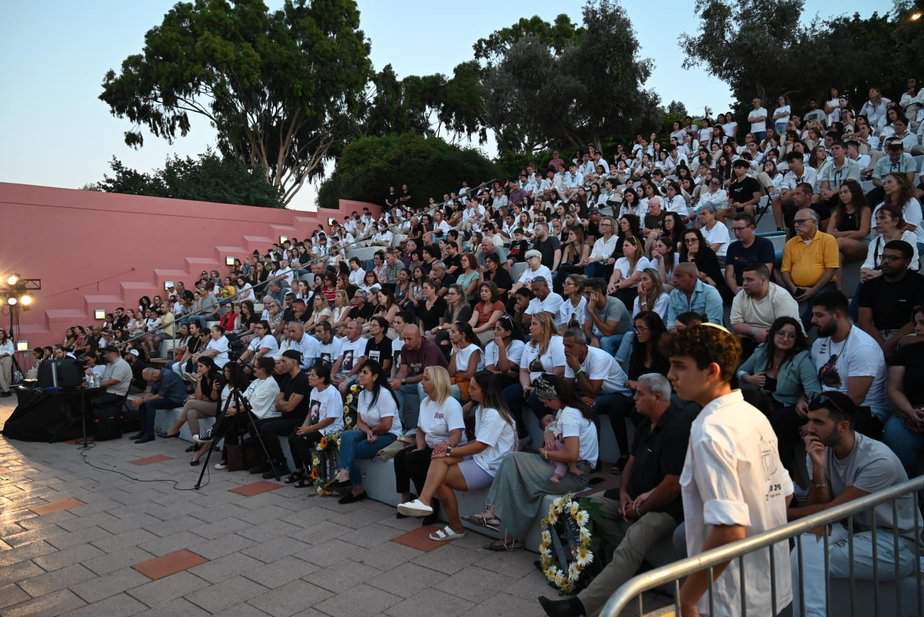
left=92, top=151, right=283, bottom=208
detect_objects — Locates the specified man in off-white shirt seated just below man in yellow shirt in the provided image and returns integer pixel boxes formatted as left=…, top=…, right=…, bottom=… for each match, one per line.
left=728, top=264, right=799, bottom=358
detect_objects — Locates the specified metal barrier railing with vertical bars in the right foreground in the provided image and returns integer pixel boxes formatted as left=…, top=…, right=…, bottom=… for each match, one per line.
left=600, top=476, right=924, bottom=617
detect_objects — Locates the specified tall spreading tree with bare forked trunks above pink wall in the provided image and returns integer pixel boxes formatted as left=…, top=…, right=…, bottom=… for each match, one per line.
left=100, top=0, right=371, bottom=204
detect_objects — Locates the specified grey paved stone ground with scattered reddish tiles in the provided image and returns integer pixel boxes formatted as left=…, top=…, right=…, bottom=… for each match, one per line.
left=0, top=399, right=576, bottom=617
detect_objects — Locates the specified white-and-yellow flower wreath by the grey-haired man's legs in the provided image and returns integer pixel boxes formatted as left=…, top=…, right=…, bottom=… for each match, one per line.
left=539, top=495, right=594, bottom=594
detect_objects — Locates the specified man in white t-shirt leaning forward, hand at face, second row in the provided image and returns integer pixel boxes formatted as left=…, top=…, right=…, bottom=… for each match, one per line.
left=563, top=328, right=632, bottom=467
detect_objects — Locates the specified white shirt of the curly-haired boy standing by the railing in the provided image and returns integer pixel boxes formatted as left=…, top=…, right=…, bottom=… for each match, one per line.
left=680, top=390, right=793, bottom=617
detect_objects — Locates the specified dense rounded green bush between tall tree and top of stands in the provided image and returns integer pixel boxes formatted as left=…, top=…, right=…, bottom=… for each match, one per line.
left=318, top=133, right=496, bottom=208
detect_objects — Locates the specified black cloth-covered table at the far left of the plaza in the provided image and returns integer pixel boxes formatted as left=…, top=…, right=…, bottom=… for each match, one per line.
left=3, top=388, right=83, bottom=442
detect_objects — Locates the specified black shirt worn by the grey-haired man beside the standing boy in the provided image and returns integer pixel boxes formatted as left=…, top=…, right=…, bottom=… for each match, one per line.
left=627, top=405, right=695, bottom=522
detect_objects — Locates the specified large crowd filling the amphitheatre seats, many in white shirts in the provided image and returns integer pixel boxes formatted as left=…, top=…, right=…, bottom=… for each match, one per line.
left=23, top=80, right=924, bottom=615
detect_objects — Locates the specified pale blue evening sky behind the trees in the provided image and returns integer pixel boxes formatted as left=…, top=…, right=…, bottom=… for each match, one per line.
left=0, top=0, right=892, bottom=209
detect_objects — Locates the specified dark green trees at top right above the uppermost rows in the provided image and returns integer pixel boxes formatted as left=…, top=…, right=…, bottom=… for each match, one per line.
left=680, top=0, right=924, bottom=114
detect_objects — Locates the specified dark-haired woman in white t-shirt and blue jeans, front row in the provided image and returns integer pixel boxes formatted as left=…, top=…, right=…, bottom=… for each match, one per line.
left=336, top=360, right=401, bottom=504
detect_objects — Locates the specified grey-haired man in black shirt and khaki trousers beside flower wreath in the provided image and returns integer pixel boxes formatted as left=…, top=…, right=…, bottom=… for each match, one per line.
left=539, top=373, right=694, bottom=617
